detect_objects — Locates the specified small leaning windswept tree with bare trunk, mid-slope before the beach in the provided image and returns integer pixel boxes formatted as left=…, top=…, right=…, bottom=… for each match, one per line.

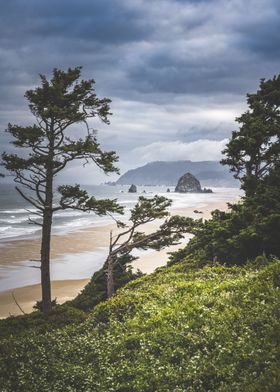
left=105, top=195, right=201, bottom=298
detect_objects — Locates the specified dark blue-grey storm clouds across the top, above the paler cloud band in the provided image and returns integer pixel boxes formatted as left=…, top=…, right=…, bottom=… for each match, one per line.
left=0, top=0, right=280, bottom=97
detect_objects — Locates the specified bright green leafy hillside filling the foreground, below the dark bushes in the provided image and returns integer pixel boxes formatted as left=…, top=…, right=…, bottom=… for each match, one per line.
left=0, top=261, right=280, bottom=392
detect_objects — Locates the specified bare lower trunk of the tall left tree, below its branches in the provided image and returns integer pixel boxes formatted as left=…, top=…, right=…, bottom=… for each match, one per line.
left=41, top=209, right=52, bottom=316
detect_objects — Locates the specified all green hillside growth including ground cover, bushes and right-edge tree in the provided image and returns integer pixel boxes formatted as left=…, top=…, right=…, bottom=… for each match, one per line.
left=0, top=72, right=280, bottom=392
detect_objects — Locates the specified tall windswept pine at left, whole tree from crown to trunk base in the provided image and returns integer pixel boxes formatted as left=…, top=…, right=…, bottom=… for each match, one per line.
left=2, top=67, right=122, bottom=315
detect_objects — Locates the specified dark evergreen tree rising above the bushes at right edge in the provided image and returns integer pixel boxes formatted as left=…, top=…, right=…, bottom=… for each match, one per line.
left=221, top=75, right=280, bottom=196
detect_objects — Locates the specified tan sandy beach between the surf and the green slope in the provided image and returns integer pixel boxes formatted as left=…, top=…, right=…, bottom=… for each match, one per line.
left=0, top=196, right=238, bottom=318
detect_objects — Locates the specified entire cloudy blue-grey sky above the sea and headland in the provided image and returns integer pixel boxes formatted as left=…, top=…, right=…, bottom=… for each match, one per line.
left=0, top=0, right=280, bottom=183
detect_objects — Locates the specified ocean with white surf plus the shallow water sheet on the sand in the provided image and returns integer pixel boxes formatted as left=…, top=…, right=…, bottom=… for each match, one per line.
left=0, top=183, right=241, bottom=291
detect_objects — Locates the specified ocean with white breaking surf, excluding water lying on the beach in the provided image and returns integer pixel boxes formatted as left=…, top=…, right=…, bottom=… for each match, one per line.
left=0, top=184, right=240, bottom=242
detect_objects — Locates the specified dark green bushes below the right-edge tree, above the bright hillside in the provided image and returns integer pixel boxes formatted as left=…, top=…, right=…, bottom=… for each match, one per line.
left=170, top=162, right=280, bottom=265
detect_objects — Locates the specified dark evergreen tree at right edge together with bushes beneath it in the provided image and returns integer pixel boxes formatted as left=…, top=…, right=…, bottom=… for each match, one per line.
left=170, top=75, right=280, bottom=264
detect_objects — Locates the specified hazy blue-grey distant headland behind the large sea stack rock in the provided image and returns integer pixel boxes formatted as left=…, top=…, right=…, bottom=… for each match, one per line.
left=116, top=161, right=239, bottom=187
